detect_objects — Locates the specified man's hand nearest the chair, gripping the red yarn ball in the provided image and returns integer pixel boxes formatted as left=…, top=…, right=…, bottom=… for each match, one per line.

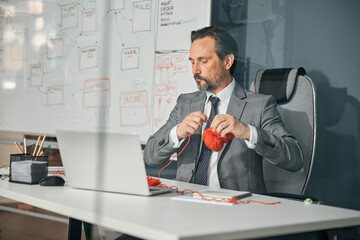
left=210, top=114, right=250, bottom=140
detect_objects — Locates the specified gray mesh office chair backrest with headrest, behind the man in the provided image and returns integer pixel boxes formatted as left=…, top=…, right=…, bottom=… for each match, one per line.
left=250, top=68, right=316, bottom=195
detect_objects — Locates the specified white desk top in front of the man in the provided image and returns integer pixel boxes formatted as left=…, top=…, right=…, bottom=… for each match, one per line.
left=0, top=180, right=360, bottom=240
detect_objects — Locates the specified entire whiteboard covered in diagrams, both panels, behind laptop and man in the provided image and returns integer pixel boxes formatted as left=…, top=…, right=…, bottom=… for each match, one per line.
left=0, top=0, right=210, bottom=141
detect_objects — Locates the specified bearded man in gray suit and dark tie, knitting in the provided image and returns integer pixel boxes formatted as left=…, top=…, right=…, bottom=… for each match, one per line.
left=144, top=27, right=303, bottom=193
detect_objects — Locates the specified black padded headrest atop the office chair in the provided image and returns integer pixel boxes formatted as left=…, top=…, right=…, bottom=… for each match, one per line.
left=253, top=67, right=306, bottom=103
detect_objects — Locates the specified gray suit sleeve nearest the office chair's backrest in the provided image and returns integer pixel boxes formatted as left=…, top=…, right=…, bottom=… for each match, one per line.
left=254, top=96, right=303, bottom=171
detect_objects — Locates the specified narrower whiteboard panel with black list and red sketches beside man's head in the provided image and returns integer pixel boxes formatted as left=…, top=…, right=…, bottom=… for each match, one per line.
left=152, top=0, right=211, bottom=131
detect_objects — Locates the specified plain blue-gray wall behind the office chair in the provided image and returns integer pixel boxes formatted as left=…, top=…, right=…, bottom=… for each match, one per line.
left=213, top=0, right=360, bottom=210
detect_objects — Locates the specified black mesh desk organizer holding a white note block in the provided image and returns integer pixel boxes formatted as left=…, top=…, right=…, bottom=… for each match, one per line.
left=9, top=154, right=49, bottom=184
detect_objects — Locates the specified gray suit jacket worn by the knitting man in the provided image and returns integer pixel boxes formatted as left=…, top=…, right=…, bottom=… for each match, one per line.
left=144, top=81, right=303, bottom=193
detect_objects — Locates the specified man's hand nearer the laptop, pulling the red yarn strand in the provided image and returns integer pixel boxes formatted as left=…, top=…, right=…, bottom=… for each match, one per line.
left=176, top=111, right=207, bottom=140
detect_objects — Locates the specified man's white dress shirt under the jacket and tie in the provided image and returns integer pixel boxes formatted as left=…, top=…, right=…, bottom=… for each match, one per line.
left=170, top=79, right=257, bottom=188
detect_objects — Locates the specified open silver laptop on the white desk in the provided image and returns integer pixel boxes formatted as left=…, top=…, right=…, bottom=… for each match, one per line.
left=56, top=130, right=170, bottom=196
